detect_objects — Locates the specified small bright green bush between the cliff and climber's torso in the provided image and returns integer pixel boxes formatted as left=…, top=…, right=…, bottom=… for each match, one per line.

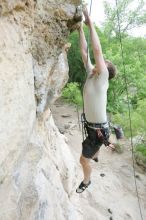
left=62, top=82, right=83, bottom=106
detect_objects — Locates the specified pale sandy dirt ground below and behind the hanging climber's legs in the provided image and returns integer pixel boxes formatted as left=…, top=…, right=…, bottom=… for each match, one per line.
left=51, top=100, right=146, bottom=220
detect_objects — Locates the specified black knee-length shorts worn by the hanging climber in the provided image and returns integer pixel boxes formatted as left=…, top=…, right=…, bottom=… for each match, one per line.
left=82, top=126, right=109, bottom=158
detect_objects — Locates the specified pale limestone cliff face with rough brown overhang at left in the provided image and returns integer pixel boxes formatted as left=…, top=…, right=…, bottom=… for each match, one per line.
left=0, top=0, right=81, bottom=220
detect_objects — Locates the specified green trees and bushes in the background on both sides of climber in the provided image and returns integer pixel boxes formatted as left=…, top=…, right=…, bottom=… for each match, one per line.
left=63, top=0, right=146, bottom=158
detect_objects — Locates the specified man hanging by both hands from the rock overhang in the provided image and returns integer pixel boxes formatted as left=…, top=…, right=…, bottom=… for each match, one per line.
left=76, top=9, right=116, bottom=193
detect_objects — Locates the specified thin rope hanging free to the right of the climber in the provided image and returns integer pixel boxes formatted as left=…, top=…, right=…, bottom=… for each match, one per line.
left=115, top=0, right=143, bottom=220
